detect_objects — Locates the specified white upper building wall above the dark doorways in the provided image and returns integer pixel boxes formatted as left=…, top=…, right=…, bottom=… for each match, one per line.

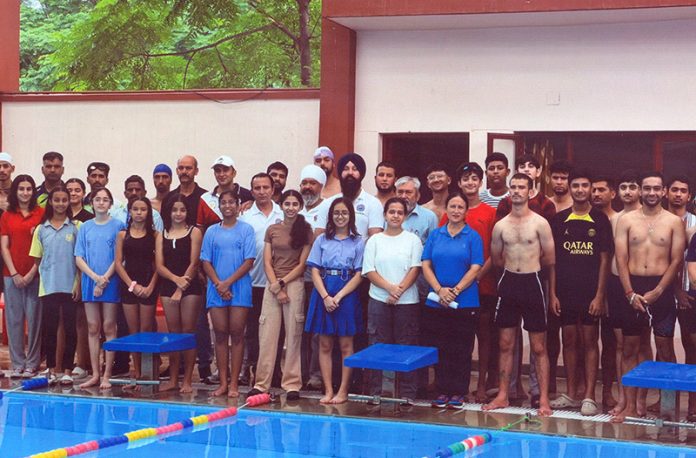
left=355, top=20, right=696, bottom=172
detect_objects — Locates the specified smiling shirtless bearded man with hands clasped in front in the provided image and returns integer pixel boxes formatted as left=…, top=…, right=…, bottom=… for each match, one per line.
left=612, top=172, right=686, bottom=423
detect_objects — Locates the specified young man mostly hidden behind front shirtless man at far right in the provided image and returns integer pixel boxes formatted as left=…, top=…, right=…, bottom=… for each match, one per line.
left=607, top=170, right=652, bottom=415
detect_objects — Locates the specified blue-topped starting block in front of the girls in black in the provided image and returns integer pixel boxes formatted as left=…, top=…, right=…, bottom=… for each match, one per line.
left=104, top=332, right=196, bottom=385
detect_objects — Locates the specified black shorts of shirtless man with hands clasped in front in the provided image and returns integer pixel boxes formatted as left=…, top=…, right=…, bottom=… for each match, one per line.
left=621, top=275, right=677, bottom=337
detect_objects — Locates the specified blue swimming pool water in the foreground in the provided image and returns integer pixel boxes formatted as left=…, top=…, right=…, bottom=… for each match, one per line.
left=0, top=393, right=696, bottom=458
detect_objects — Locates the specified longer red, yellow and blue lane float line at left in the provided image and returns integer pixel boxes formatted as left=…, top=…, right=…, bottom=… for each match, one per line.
left=24, top=393, right=271, bottom=458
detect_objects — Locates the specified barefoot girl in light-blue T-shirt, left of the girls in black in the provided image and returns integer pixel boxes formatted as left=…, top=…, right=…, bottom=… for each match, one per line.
left=75, top=188, right=125, bottom=390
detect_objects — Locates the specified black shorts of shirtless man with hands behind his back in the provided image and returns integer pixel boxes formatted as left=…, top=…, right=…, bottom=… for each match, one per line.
left=495, top=270, right=546, bottom=332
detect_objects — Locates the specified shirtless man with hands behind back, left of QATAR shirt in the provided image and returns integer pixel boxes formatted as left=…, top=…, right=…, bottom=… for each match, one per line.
left=483, top=173, right=555, bottom=416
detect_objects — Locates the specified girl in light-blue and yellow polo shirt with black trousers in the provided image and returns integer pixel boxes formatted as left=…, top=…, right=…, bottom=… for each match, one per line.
left=29, top=186, right=80, bottom=385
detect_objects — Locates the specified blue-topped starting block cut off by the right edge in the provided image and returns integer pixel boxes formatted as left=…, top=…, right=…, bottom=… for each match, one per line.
left=621, top=361, right=696, bottom=421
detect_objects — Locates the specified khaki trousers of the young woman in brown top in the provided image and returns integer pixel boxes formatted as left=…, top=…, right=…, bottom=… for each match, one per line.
left=254, top=278, right=305, bottom=392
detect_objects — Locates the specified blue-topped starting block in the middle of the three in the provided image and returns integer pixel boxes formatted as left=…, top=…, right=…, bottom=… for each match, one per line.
left=344, top=343, right=438, bottom=412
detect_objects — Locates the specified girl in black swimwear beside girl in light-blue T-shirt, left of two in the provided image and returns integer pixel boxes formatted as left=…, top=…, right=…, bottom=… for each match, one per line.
left=114, top=197, right=158, bottom=378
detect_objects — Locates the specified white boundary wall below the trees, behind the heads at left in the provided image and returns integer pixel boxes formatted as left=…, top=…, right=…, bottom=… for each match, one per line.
left=2, top=99, right=319, bottom=197
